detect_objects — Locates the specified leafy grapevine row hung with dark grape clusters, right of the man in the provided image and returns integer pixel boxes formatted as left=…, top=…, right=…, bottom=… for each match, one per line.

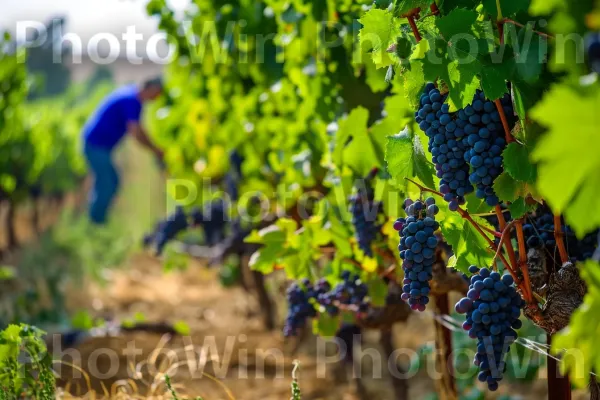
left=148, top=0, right=600, bottom=389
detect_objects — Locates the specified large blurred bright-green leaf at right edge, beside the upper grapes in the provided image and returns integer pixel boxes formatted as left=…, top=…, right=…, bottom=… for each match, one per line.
left=531, top=84, right=600, bottom=236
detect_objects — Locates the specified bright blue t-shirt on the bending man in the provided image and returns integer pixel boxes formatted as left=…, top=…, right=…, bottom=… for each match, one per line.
left=83, top=85, right=142, bottom=150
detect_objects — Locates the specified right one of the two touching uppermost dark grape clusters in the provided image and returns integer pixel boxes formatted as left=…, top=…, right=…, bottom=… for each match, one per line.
left=455, top=90, right=513, bottom=207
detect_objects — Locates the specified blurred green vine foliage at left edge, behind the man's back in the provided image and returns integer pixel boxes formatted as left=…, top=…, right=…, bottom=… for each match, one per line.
left=0, top=34, right=108, bottom=203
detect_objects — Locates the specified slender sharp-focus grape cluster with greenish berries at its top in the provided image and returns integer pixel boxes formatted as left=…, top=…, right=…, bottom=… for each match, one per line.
left=394, top=197, right=440, bottom=311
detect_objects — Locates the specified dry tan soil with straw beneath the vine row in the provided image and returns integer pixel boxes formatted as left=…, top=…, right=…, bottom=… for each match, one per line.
left=54, top=255, right=584, bottom=400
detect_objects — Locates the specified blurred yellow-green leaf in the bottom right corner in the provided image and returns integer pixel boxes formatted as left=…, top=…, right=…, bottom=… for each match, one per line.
left=552, top=261, right=600, bottom=387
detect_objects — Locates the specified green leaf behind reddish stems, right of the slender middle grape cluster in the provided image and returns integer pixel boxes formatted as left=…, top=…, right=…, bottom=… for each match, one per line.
left=440, top=212, right=494, bottom=273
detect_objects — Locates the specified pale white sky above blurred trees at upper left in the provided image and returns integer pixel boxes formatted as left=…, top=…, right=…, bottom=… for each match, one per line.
left=0, top=0, right=190, bottom=55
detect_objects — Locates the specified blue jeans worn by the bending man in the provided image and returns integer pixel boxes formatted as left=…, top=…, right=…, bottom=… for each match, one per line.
left=84, top=143, right=119, bottom=224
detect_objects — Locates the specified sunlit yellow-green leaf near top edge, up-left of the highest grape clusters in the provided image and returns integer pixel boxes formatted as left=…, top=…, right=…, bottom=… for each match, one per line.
left=358, top=8, right=400, bottom=68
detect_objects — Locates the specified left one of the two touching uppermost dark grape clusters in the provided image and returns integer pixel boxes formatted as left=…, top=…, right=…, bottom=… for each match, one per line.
left=415, top=83, right=474, bottom=211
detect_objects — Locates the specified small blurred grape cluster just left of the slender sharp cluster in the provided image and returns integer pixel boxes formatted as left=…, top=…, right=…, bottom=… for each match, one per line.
left=350, top=191, right=380, bottom=257
